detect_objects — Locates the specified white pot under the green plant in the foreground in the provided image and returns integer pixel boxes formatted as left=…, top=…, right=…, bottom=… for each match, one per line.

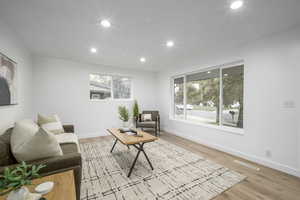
left=6, top=186, right=42, bottom=200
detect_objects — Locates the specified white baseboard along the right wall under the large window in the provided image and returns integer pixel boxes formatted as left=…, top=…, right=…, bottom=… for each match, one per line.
left=164, top=129, right=300, bottom=177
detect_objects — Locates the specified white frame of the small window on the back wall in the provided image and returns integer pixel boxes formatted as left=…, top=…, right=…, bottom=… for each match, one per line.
left=88, top=72, right=133, bottom=102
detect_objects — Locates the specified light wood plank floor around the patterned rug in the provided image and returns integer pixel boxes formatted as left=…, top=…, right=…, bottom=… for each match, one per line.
left=81, top=133, right=300, bottom=200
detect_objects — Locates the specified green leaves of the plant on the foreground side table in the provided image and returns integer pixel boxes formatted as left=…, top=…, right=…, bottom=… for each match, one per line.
left=0, top=162, right=46, bottom=196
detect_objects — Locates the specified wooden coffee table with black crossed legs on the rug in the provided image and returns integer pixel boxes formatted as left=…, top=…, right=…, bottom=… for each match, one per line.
left=107, top=128, right=158, bottom=177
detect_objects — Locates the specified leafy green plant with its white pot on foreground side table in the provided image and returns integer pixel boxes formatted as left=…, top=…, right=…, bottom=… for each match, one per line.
left=0, top=162, right=45, bottom=200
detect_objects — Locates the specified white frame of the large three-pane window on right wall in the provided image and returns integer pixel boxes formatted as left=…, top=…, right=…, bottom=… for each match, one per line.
left=169, top=60, right=245, bottom=135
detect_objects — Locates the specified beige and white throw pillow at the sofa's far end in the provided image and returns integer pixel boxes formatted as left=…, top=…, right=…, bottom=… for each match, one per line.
left=38, top=114, right=65, bottom=134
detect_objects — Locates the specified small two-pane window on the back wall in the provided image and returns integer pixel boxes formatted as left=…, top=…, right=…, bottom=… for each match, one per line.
left=90, top=74, right=131, bottom=100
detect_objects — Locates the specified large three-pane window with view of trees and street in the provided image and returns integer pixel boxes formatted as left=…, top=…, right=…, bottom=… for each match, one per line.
left=172, top=64, right=244, bottom=128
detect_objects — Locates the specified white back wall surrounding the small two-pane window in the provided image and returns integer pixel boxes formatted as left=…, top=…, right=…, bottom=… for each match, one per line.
left=34, top=57, right=157, bottom=137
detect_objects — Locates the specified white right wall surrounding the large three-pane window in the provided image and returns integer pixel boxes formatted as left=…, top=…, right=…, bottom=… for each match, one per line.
left=158, top=25, right=300, bottom=175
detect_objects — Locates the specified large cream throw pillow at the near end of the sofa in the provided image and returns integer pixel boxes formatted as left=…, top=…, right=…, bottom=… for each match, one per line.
left=11, top=121, right=63, bottom=162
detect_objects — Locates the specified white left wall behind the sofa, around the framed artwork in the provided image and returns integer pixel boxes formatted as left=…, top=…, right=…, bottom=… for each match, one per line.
left=0, top=20, right=32, bottom=134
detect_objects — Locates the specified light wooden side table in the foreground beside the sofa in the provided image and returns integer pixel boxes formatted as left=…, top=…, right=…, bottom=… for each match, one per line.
left=0, top=170, right=76, bottom=200
